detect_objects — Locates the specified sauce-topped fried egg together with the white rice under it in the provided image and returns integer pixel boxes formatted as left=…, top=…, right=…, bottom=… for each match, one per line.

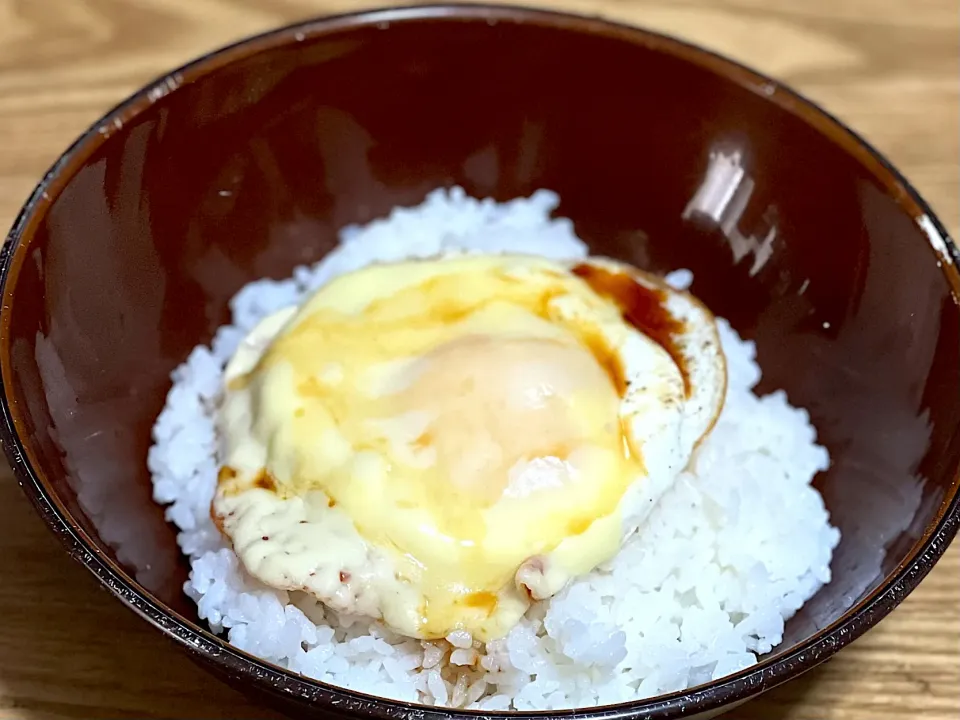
left=150, top=191, right=838, bottom=709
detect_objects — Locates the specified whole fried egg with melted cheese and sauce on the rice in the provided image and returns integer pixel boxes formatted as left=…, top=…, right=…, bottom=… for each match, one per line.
left=211, top=255, right=726, bottom=641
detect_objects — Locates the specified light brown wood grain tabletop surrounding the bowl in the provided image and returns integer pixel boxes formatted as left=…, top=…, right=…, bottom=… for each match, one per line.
left=0, top=0, right=960, bottom=720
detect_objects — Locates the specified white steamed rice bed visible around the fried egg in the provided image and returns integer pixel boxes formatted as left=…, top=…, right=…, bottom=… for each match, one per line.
left=149, top=189, right=840, bottom=710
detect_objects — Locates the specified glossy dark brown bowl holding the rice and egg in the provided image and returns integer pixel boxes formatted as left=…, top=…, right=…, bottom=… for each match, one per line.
left=0, top=6, right=960, bottom=720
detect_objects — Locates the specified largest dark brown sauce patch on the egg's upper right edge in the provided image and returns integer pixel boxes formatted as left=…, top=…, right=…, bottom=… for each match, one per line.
left=572, top=263, right=690, bottom=397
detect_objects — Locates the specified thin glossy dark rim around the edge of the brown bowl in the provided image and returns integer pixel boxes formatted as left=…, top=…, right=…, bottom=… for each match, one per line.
left=0, top=3, right=960, bottom=720
